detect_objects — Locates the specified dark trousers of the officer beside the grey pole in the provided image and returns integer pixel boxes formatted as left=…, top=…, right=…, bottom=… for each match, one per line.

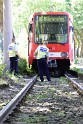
left=10, top=57, right=18, bottom=74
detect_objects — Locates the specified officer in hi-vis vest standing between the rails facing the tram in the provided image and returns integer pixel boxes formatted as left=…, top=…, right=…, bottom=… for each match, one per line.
left=34, top=41, right=51, bottom=82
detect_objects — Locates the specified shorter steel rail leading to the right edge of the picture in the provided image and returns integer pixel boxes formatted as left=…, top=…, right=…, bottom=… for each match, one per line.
left=65, top=74, right=83, bottom=95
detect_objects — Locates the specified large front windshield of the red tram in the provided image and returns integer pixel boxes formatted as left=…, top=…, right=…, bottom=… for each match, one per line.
left=34, top=15, right=68, bottom=44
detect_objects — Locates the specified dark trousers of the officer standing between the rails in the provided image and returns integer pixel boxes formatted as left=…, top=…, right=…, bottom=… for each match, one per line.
left=37, top=59, right=50, bottom=81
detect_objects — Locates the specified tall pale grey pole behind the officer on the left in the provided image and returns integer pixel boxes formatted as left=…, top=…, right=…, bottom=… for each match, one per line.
left=3, top=0, right=12, bottom=71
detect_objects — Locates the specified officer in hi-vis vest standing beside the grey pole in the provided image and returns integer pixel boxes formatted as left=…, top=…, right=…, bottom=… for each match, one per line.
left=8, top=38, right=20, bottom=76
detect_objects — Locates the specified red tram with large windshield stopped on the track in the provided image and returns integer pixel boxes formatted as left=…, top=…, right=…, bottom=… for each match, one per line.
left=28, top=12, right=74, bottom=76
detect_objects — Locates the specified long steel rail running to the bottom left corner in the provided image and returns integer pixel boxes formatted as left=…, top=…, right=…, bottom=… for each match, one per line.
left=0, top=75, right=37, bottom=124
